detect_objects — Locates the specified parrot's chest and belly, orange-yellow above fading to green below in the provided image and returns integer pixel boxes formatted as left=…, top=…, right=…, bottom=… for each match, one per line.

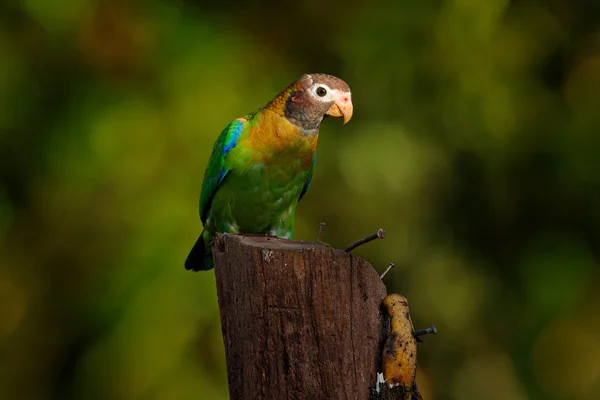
left=213, top=114, right=317, bottom=234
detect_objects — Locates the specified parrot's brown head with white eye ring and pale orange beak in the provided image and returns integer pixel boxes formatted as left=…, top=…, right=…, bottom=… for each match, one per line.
left=282, top=74, right=353, bottom=129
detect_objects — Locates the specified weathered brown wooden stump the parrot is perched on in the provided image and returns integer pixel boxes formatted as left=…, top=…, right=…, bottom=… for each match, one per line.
left=212, top=235, right=386, bottom=400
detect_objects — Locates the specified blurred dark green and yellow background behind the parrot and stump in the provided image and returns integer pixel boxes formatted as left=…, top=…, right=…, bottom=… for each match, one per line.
left=0, top=0, right=600, bottom=400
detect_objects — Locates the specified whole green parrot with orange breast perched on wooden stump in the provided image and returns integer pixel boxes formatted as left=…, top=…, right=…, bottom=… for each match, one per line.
left=185, top=73, right=353, bottom=271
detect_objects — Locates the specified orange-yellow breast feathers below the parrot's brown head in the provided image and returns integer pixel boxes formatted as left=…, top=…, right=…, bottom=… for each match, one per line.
left=246, top=110, right=318, bottom=168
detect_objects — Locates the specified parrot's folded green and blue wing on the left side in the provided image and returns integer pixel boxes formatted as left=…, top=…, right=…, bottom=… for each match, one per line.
left=200, top=116, right=249, bottom=224
